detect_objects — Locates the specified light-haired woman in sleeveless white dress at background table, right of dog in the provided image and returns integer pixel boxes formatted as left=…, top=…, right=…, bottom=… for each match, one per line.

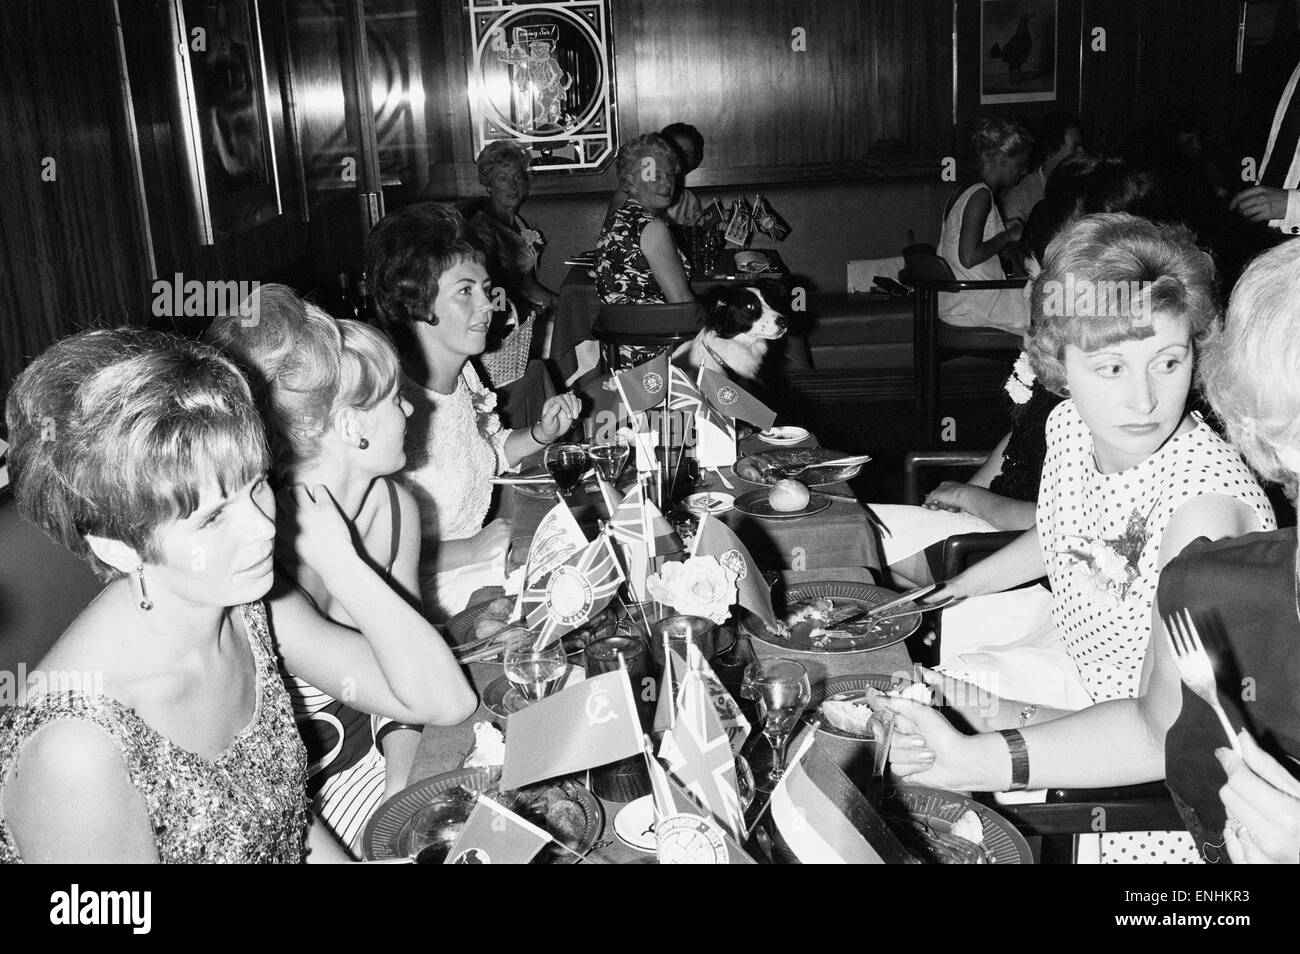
left=939, top=120, right=1034, bottom=334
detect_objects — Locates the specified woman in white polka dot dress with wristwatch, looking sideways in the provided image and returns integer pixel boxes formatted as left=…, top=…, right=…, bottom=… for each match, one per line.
left=878, top=214, right=1275, bottom=863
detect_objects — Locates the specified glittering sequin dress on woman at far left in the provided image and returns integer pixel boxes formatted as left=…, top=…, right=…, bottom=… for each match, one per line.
left=0, top=603, right=307, bottom=864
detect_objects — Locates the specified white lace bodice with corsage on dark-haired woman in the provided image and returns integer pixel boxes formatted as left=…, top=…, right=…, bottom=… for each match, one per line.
left=400, top=364, right=510, bottom=539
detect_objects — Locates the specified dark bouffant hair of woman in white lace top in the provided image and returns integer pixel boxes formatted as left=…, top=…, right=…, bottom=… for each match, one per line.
left=365, top=201, right=484, bottom=339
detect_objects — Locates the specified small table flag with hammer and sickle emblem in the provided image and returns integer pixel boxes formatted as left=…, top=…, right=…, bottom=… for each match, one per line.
left=501, top=669, right=644, bottom=790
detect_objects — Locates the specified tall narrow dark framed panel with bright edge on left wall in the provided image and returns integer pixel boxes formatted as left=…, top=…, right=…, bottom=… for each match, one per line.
left=173, top=0, right=282, bottom=244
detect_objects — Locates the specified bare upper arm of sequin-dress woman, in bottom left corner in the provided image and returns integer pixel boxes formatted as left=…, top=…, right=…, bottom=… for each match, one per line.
left=0, top=720, right=159, bottom=864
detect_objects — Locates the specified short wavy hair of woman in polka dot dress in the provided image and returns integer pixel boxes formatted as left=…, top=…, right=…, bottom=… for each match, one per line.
left=1024, top=212, right=1218, bottom=394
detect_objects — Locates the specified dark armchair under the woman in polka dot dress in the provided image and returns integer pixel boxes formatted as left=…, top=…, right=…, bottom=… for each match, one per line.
left=927, top=530, right=1187, bottom=864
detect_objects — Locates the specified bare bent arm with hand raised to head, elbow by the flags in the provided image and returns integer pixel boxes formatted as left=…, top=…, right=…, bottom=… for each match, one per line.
left=268, top=485, right=477, bottom=725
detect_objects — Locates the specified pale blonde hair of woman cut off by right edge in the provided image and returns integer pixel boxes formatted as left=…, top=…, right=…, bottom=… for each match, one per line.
left=1200, top=240, right=1300, bottom=500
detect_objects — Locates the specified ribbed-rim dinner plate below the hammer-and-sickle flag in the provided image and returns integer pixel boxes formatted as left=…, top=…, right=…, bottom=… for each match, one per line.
left=361, top=768, right=605, bottom=864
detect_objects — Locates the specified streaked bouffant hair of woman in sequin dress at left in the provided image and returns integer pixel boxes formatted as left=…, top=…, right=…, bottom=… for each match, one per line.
left=5, top=329, right=269, bottom=580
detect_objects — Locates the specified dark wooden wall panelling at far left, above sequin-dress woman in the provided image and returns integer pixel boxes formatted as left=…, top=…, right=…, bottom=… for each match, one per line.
left=0, top=0, right=147, bottom=400
